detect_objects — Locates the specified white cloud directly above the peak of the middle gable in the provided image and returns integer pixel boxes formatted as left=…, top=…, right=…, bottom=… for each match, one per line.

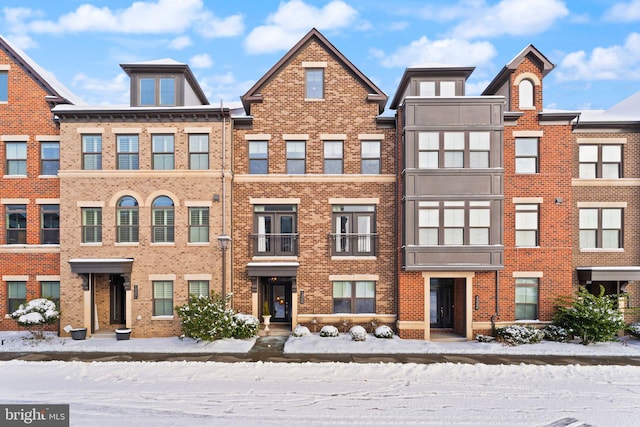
left=245, top=0, right=358, bottom=53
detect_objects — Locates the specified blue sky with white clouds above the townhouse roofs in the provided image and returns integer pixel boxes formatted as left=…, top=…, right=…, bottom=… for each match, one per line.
left=0, top=0, right=640, bottom=110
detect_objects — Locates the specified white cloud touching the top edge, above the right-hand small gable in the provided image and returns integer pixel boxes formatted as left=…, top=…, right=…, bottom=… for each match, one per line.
left=453, top=0, right=569, bottom=39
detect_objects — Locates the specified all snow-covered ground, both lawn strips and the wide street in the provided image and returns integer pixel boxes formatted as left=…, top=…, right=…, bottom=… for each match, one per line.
left=0, top=333, right=640, bottom=427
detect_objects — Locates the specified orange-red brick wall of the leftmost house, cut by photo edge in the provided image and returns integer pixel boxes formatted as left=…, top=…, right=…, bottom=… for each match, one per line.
left=0, top=44, right=59, bottom=330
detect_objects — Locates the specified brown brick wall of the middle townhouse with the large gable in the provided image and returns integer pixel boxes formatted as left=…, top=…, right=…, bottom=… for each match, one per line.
left=233, top=41, right=396, bottom=326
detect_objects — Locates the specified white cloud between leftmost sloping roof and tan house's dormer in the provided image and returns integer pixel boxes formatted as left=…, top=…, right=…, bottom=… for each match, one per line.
left=72, top=73, right=129, bottom=105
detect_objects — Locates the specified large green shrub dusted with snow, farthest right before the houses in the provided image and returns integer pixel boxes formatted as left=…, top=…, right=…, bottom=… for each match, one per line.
left=553, top=286, right=624, bottom=345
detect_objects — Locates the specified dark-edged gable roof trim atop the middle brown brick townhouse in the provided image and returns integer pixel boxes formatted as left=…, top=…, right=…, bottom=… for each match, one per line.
left=240, top=28, right=387, bottom=115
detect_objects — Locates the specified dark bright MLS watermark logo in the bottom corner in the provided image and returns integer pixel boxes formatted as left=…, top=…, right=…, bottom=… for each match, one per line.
left=0, top=404, right=69, bottom=427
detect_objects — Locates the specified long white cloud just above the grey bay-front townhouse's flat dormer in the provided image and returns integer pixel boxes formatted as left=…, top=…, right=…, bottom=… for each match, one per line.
left=378, top=36, right=496, bottom=67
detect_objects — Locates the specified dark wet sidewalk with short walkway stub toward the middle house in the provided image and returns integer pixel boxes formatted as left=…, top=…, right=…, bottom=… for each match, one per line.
left=0, top=336, right=640, bottom=366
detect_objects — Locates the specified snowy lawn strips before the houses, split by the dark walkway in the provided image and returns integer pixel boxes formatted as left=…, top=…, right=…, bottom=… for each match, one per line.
left=0, top=332, right=640, bottom=357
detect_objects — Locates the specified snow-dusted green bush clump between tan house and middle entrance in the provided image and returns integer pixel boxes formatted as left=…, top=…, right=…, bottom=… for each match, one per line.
left=176, top=293, right=260, bottom=341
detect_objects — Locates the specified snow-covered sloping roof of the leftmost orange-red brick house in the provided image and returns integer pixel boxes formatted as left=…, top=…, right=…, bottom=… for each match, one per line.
left=0, top=35, right=84, bottom=105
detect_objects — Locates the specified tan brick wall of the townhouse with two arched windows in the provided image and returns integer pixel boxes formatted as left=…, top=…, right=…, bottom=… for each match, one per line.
left=60, top=122, right=231, bottom=337
